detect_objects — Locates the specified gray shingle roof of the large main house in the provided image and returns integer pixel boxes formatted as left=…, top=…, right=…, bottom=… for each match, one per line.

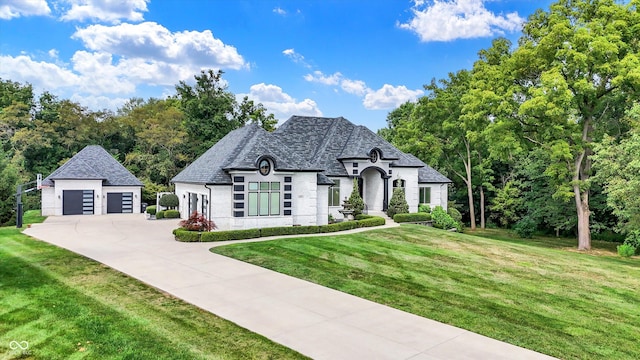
left=171, top=116, right=450, bottom=184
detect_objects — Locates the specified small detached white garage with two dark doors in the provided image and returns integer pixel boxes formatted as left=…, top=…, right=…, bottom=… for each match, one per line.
left=42, top=145, right=142, bottom=216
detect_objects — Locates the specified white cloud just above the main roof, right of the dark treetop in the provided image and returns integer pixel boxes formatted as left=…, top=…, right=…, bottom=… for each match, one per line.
left=245, top=83, right=322, bottom=120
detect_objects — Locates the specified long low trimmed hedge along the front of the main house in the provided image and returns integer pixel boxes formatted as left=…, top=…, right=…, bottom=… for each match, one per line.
left=173, top=216, right=385, bottom=242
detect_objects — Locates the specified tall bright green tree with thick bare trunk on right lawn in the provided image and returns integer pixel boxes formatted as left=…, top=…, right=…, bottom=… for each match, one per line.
left=512, top=0, right=640, bottom=250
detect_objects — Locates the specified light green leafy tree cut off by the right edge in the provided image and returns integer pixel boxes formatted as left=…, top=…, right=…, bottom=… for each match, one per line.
left=591, top=104, right=640, bottom=233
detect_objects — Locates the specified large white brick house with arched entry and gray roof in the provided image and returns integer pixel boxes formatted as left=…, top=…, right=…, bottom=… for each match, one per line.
left=171, top=116, right=451, bottom=229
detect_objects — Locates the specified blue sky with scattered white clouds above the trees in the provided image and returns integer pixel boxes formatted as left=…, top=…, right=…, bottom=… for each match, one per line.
left=0, top=0, right=551, bottom=131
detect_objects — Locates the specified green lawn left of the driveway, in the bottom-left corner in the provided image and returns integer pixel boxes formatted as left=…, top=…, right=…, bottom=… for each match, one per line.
left=0, top=214, right=304, bottom=359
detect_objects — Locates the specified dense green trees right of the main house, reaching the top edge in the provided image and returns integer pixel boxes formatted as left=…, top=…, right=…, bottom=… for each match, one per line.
left=379, top=0, right=640, bottom=249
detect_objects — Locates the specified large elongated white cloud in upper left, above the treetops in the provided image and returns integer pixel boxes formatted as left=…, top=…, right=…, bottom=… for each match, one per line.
left=72, top=22, right=246, bottom=72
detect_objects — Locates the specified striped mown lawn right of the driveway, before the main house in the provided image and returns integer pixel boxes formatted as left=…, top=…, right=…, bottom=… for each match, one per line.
left=212, top=225, right=640, bottom=359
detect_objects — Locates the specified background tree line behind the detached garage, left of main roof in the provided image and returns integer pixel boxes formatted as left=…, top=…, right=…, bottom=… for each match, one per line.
left=0, top=70, right=277, bottom=224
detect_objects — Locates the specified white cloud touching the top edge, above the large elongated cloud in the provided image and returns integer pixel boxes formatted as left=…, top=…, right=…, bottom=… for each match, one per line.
left=60, top=0, right=149, bottom=24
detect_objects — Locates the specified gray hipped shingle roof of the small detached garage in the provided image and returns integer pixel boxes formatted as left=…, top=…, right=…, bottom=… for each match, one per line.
left=42, top=145, right=143, bottom=186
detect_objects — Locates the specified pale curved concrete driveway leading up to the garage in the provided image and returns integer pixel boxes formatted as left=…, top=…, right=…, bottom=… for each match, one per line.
left=24, top=215, right=550, bottom=360
